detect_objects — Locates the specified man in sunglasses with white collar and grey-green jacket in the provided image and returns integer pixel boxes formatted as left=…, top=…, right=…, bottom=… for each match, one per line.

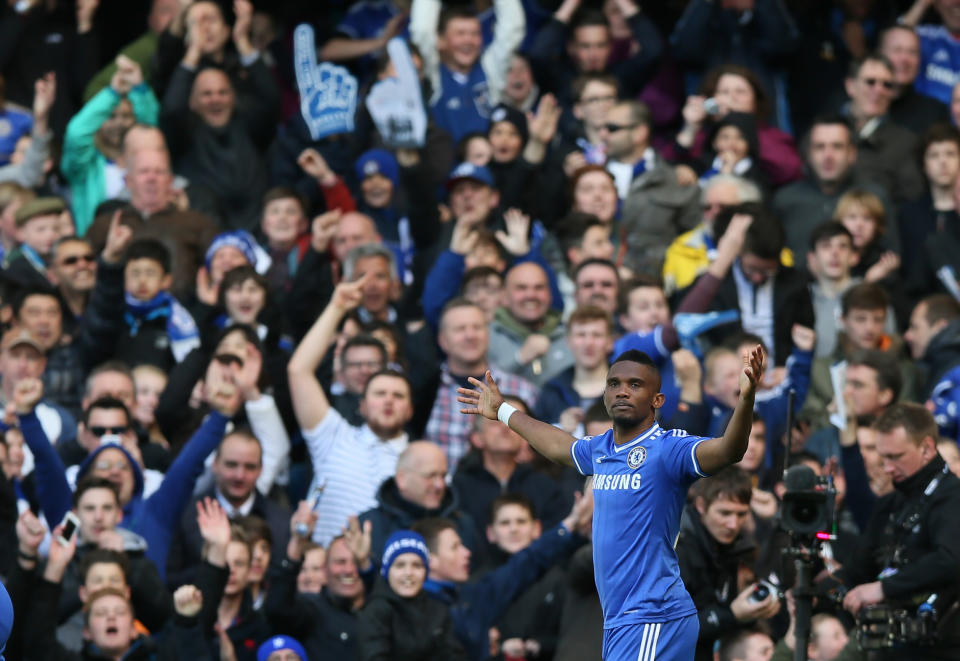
left=600, top=101, right=700, bottom=275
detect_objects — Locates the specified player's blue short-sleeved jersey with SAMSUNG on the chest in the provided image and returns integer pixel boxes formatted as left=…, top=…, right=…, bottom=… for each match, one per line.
left=570, top=423, right=708, bottom=629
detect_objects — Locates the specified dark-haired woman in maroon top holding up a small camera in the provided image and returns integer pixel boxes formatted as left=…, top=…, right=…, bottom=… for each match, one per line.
left=664, top=64, right=803, bottom=187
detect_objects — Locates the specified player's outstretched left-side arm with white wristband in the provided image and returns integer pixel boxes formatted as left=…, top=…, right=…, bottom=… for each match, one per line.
left=457, top=370, right=576, bottom=466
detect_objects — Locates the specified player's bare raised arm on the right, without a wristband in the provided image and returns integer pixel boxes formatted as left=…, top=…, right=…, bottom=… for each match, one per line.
left=697, top=344, right=764, bottom=475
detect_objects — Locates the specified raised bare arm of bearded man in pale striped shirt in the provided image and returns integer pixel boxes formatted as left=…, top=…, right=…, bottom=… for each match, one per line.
left=287, top=276, right=366, bottom=429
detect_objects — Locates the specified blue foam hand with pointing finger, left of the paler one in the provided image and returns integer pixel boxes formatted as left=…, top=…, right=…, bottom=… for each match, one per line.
left=293, top=23, right=357, bottom=140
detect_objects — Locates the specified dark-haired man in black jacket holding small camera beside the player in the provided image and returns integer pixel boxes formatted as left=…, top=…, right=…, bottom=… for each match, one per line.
left=677, top=467, right=780, bottom=661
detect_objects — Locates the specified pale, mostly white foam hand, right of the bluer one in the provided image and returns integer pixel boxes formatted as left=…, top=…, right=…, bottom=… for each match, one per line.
left=366, top=37, right=427, bottom=148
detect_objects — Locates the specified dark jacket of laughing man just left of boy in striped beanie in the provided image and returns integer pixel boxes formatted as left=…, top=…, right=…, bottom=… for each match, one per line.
left=263, top=551, right=357, bottom=661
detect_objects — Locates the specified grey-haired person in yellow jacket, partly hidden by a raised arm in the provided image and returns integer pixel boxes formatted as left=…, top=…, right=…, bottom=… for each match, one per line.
left=663, top=174, right=760, bottom=296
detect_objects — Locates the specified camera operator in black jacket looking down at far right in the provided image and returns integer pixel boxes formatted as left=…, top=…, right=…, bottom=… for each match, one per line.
left=839, top=403, right=960, bottom=661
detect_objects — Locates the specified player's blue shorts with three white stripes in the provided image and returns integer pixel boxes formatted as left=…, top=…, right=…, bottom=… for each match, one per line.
left=603, top=613, right=700, bottom=661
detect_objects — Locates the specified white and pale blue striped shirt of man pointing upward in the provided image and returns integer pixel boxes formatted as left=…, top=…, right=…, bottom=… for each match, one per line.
left=302, top=407, right=408, bottom=546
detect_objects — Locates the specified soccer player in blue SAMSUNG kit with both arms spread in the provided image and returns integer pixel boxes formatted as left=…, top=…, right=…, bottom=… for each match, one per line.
left=457, top=345, right=764, bottom=661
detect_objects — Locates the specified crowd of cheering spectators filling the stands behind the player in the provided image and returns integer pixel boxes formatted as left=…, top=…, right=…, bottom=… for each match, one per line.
left=0, top=0, right=960, bottom=661
